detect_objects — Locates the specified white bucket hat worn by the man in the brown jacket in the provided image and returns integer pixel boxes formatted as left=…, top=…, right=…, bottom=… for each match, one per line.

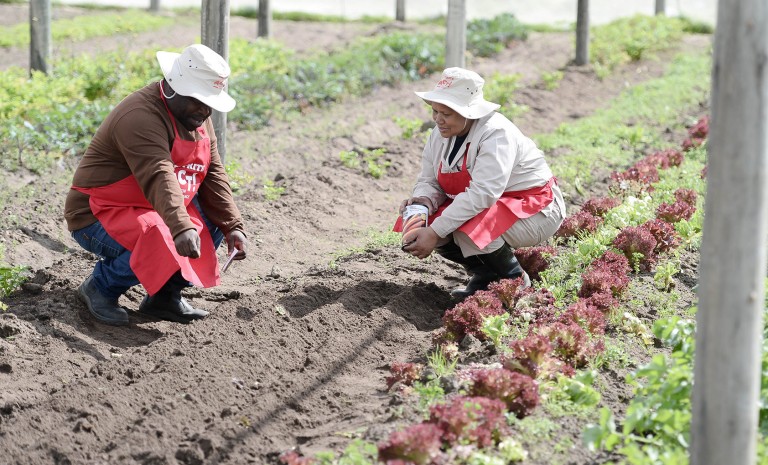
left=157, top=44, right=235, bottom=113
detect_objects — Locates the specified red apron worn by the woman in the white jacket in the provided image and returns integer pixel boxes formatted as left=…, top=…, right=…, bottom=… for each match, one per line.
left=393, top=144, right=556, bottom=249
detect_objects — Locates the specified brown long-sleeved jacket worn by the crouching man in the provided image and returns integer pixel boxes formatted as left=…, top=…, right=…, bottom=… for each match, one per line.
left=64, top=82, right=243, bottom=237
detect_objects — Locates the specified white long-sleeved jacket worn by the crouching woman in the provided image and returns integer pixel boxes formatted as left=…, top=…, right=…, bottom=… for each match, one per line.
left=412, top=112, right=552, bottom=237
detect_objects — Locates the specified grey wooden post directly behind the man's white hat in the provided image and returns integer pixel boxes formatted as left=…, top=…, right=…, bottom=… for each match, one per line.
left=201, top=0, right=229, bottom=161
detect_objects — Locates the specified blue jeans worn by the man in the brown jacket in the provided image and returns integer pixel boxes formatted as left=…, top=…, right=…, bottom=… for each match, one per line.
left=72, top=196, right=224, bottom=299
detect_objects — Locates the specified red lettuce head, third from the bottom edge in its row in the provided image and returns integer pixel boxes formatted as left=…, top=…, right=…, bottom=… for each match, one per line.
left=468, top=368, right=539, bottom=418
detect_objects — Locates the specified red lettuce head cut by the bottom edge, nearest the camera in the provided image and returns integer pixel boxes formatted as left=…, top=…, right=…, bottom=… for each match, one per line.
left=379, top=423, right=443, bottom=465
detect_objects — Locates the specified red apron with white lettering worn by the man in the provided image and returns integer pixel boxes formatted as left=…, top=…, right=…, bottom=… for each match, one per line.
left=72, top=84, right=221, bottom=295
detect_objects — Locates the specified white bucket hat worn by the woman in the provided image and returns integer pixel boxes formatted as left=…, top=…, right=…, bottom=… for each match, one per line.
left=416, top=68, right=501, bottom=119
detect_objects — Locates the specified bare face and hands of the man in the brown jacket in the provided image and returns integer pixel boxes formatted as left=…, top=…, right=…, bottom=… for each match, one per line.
left=163, top=79, right=247, bottom=260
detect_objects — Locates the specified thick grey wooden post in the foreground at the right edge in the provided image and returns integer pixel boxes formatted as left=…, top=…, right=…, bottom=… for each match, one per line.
left=690, top=0, right=768, bottom=465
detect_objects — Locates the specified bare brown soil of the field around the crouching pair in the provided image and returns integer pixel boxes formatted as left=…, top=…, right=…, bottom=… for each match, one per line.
left=0, top=6, right=707, bottom=464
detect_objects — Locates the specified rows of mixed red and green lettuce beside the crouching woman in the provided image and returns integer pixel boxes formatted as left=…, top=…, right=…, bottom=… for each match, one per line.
left=282, top=112, right=708, bottom=465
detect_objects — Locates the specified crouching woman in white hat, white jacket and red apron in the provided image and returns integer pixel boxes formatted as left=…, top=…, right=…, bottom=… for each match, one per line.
left=395, top=68, right=565, bottom=298
